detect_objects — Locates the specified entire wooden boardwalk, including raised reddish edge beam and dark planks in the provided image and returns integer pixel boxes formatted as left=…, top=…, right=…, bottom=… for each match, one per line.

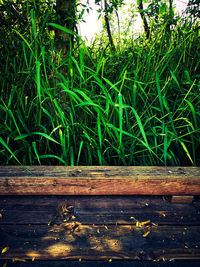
left=0, top=166, right=200, bottom=267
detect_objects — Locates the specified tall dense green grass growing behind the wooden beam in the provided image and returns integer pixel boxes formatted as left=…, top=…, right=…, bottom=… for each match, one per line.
left=0, top=1, right=200, bottom=166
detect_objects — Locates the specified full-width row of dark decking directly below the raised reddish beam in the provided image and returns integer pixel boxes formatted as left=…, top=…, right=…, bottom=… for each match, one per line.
left=0, top=196, right=200, bottom=225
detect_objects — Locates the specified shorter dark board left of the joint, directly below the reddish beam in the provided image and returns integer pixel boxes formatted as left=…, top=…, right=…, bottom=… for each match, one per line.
left=0, top=196, right=74, bottom=225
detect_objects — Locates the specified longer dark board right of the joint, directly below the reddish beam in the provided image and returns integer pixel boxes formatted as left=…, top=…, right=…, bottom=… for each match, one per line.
left=74, top=196, right=200, bottom=225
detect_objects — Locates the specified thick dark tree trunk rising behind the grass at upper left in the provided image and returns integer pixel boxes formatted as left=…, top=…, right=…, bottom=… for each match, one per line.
left=55, top=0, right=76, bottom=54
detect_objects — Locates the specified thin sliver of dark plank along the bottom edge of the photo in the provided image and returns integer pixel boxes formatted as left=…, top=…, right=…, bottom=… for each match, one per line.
left=0, top=259, right=200, bottom=267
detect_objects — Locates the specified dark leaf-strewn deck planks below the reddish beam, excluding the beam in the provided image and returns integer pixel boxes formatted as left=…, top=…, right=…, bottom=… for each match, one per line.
left=0, top=196, right=200, bottom=267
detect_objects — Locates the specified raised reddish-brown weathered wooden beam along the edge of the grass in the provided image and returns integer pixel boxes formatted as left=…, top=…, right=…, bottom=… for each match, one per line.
left=0, top=166, right=200, bottom=195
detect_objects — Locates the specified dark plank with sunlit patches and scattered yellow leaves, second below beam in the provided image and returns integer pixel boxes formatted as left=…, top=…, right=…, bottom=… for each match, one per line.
left=0, top=224, right=200, bottom=260
